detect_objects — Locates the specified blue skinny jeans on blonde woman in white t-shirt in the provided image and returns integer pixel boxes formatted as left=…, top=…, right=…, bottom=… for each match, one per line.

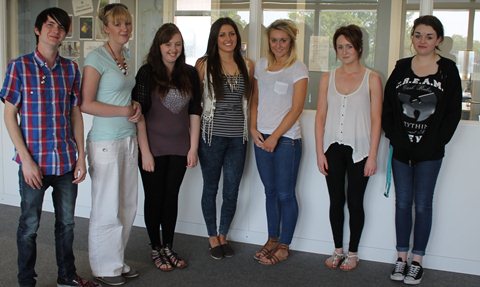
left=255, top=135, right=302, bottom=244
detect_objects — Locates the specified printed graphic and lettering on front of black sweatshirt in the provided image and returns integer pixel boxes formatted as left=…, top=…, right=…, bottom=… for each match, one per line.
left=396, top=71, right=443, bottom=143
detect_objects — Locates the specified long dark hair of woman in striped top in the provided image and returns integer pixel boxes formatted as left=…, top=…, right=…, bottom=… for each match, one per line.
left=201, top=17, right=251, bottom=99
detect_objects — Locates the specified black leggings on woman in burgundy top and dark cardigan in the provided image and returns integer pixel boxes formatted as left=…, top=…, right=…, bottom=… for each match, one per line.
left=139, top=155, right=187, bottom=248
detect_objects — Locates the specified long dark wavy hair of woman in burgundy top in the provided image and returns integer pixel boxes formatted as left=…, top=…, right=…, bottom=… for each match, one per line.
left=146, top=23, right=193, bottom=97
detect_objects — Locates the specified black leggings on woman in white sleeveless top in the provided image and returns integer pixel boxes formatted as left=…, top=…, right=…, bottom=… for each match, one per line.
left=325, top=143, right=368, bottom=252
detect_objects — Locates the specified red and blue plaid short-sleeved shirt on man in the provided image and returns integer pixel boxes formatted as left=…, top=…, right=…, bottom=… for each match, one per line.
left=0, top=50, right=80, bottom=175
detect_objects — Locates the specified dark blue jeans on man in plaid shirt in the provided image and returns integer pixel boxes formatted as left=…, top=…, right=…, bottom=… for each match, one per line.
left=17, top=168, right=77, bottom=286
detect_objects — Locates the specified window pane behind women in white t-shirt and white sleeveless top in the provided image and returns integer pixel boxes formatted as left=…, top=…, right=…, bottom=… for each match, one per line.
left=261, top=0, right=377, bottom=109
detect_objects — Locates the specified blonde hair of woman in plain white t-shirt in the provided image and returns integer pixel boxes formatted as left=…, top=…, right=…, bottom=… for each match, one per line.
left=267, top=19, right=298, bottom=67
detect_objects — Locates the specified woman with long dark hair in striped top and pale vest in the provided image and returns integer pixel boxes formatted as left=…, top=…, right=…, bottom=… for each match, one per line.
left=196, top=18, right=253, bottom=259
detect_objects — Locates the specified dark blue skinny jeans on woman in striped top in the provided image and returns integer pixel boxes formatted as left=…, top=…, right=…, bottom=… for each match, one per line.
left=198, top=136, right=247, bottom=236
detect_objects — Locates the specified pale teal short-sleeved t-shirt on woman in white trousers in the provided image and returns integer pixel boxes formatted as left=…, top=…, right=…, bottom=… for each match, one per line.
left=84, top=46, right=136, bottom=141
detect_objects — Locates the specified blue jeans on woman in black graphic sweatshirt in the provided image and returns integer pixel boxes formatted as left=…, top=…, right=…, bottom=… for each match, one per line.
left=392, top=159, right=442, bottom=256
